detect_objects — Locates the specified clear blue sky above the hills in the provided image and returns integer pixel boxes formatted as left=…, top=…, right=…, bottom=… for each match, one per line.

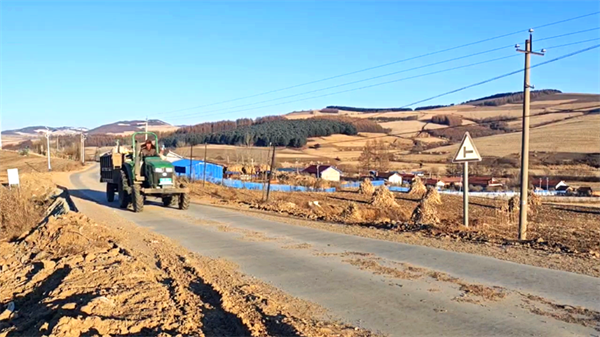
left=0, top=0, right=600, bottom=130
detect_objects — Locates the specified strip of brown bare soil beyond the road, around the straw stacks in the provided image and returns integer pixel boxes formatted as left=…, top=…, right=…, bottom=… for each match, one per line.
left=192, top=184, right=600, bottom=277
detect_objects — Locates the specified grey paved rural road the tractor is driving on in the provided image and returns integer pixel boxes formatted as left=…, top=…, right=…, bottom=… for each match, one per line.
left=68, top=165, right=600, bottom=336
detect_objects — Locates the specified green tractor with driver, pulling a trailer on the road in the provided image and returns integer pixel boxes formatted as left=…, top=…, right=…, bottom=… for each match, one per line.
left=100, top=132, right=190, bottom=213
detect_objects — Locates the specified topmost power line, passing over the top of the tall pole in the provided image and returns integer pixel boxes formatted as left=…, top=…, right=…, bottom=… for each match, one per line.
left=158, top=11, right=600, bottom=114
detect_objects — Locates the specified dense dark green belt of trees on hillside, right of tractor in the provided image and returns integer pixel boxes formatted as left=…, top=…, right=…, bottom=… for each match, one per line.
left=162, top=119, right=357, bottom=147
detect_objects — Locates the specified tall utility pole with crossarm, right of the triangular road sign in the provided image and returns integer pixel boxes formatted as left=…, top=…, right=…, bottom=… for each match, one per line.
left=515, top=29, right=545, bottom=240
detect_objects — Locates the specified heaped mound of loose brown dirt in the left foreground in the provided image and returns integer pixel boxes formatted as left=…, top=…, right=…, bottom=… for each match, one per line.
left=0, top=175, right=380, bottom=336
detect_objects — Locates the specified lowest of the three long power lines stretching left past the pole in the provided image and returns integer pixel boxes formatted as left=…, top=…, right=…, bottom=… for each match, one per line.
left=173, top=39, right=598, bottom=120
